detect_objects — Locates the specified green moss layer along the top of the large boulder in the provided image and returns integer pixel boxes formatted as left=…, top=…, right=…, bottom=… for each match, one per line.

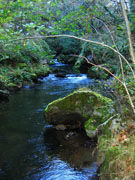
left=45, top=88, right=112, bottom=112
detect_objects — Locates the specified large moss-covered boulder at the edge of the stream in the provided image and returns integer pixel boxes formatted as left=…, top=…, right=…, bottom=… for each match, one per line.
left=45, top=89, right=112, bottom=137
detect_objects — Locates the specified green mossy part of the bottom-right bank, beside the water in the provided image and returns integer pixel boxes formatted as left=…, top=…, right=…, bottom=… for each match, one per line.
left=98, top=134, right=126, bottom=180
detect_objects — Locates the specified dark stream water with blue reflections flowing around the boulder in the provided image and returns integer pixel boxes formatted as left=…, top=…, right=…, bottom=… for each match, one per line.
left=0, top=62, right=97, bottom=180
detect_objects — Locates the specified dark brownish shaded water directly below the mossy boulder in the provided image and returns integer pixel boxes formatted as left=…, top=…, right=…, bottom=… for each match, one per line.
left=44, top=128, right=97, bottom=179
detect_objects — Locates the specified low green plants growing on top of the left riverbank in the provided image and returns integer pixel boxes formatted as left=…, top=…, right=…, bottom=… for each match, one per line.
left=0, top=63, right=50, bottom=89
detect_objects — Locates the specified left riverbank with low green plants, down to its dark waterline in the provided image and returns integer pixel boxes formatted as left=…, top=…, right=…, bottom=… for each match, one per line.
left=0, top=63, right=51, bottom=100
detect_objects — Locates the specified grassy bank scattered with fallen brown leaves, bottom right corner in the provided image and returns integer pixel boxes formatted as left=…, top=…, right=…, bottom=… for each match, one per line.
left=98, top=122, right=135, bottom=180
